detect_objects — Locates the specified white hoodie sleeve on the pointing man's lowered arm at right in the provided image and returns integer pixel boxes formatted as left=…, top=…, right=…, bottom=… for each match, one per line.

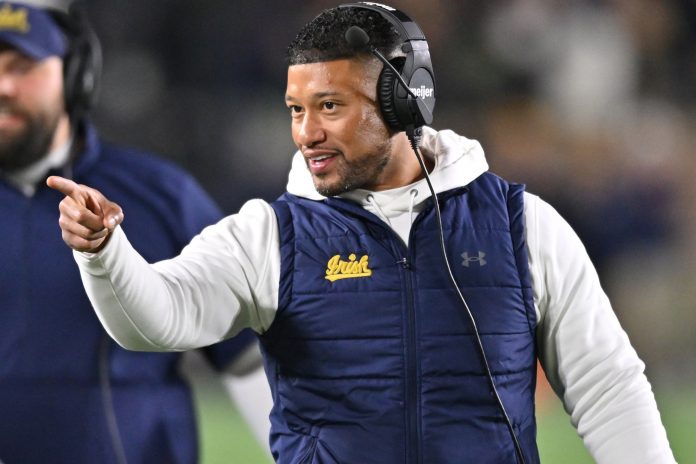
left=525, top=194, right=675, bottom=464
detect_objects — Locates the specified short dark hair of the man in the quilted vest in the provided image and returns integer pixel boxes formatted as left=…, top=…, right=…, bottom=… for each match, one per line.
left=287, top=8, right=400, bottom=66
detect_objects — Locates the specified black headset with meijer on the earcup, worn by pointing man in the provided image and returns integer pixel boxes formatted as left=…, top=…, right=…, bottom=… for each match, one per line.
left=338, top=2, right=435, bottom=132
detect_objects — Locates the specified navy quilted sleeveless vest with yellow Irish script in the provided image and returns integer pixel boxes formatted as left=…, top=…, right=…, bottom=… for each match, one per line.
left=261, top=174, right=539, bottom=464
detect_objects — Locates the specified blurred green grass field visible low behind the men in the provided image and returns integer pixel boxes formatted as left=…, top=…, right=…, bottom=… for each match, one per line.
left=194, top=379, right=696, bottom=464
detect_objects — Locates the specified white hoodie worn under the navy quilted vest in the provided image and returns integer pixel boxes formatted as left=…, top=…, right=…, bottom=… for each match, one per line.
left=75, top=127, right=675, bottom=464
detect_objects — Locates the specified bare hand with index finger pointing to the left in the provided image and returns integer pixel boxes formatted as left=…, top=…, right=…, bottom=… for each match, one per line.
left=46, top=176, right=123, bottom=253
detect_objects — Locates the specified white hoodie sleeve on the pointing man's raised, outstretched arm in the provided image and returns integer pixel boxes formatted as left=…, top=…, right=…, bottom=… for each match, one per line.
left=74, top=200, right=280, bottom=351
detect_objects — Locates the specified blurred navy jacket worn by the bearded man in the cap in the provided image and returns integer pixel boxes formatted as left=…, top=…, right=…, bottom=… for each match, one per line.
left=0, top=123, right=253, bottom=464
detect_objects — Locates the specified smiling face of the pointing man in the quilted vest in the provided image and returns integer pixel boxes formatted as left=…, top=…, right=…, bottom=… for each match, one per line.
left=285, top=59, right=416, bottom=196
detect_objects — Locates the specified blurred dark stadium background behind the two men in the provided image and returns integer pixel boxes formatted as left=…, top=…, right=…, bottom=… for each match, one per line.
left=64, top=0, right=696, bottom=463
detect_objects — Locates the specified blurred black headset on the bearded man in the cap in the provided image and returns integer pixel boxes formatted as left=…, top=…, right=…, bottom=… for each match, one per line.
left=46, top=3, right=102, bottom=121
